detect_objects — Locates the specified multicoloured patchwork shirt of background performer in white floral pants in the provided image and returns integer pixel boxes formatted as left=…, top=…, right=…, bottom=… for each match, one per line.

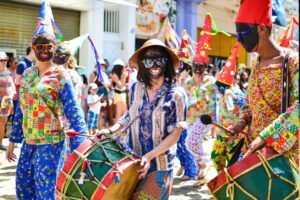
left=183, top=76, right=217, bottom=122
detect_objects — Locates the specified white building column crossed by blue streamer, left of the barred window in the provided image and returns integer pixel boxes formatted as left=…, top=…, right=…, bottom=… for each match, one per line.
left=79, top=0, right=104, bottom=76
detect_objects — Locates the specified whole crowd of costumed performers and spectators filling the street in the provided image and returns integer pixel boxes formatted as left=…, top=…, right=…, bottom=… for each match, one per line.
left=0, top=0, right=299, bottom=200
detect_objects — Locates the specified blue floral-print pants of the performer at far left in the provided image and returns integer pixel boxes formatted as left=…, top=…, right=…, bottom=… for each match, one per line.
left=16, top=141, right=64, bottom=200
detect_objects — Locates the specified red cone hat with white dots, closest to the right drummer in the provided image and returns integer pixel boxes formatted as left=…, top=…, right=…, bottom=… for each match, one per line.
left=218, top=42, right=241, bottom=85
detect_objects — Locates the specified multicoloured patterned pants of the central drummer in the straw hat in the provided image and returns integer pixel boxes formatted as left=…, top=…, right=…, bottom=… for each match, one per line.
left=132, top=170, right=173, bottom=200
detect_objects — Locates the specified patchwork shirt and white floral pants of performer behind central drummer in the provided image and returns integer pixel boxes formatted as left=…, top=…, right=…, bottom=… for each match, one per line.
left=184, top=76, right=217, bottom=173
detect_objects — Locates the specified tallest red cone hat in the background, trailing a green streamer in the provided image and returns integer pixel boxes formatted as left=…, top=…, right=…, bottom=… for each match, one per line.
left=193, top=14, right=211, bottom=64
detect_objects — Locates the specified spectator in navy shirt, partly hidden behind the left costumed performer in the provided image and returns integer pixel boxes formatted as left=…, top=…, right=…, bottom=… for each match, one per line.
left=15, top=47, right=35, bottom=85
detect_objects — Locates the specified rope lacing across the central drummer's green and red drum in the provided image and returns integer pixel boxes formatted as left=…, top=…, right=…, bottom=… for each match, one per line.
left=56, top=138, right=137, bottom=200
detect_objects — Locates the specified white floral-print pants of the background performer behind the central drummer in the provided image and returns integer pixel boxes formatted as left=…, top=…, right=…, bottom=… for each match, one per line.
left=185, top=119, right=212, bottom=174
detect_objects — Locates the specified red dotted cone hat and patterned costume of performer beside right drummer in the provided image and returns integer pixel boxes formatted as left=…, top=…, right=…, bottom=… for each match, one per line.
left=211, top=42, right=245, bottom=172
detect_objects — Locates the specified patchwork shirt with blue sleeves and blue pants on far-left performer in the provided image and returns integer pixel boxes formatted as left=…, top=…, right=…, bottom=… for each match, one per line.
left=9, top=66, right=87, bottom=200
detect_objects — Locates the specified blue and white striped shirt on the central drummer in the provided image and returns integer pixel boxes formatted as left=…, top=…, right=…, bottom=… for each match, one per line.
left=118, top=82, right=188, bottom=172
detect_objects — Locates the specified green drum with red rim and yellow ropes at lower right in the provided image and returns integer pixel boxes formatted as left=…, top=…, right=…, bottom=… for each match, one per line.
left=208, top=147, right=299, bottom=200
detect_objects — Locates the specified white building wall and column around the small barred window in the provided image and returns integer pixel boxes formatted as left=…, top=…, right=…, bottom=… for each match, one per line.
left=79, top=0, right=136, bottom=75
